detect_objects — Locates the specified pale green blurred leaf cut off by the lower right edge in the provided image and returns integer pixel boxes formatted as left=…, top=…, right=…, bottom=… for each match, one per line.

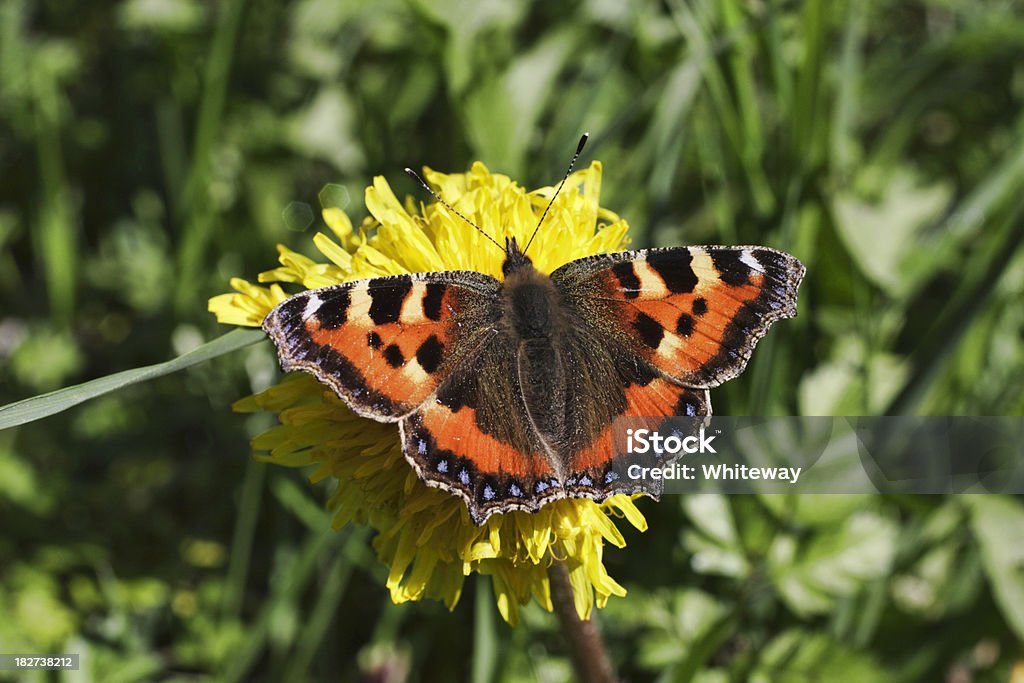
left=964, top=496, right=1024, bottom=640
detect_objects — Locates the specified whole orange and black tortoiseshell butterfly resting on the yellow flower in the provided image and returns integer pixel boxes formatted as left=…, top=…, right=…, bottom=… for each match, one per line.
left=263, top=136, right=804, bottom=524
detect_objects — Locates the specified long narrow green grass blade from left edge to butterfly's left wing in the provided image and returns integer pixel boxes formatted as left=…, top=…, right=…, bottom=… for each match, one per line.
left=0, top=330, right=266, bottom=429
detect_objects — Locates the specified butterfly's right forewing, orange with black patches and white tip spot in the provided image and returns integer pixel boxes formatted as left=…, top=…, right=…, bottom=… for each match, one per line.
left=551, top=247, right=804, bottom=388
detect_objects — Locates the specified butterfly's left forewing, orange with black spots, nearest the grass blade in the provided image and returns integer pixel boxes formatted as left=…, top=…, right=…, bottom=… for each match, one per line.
left=263, top=271, right=499, bottom=422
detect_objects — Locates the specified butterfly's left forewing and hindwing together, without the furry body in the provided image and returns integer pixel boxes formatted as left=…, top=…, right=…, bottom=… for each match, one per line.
left=263, top=271, right=564, bottom=523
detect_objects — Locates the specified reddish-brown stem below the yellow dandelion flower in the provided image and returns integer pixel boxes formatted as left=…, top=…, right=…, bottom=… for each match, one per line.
left=548, top=562, right=617, bottom=683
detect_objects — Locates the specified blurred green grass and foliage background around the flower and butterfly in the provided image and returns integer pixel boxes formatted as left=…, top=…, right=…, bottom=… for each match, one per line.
left=0, top=0, right=1024, bottom=683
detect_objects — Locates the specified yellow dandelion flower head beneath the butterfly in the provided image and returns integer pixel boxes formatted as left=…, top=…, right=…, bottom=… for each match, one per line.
left=209, top=162, right=646, bottom=624
